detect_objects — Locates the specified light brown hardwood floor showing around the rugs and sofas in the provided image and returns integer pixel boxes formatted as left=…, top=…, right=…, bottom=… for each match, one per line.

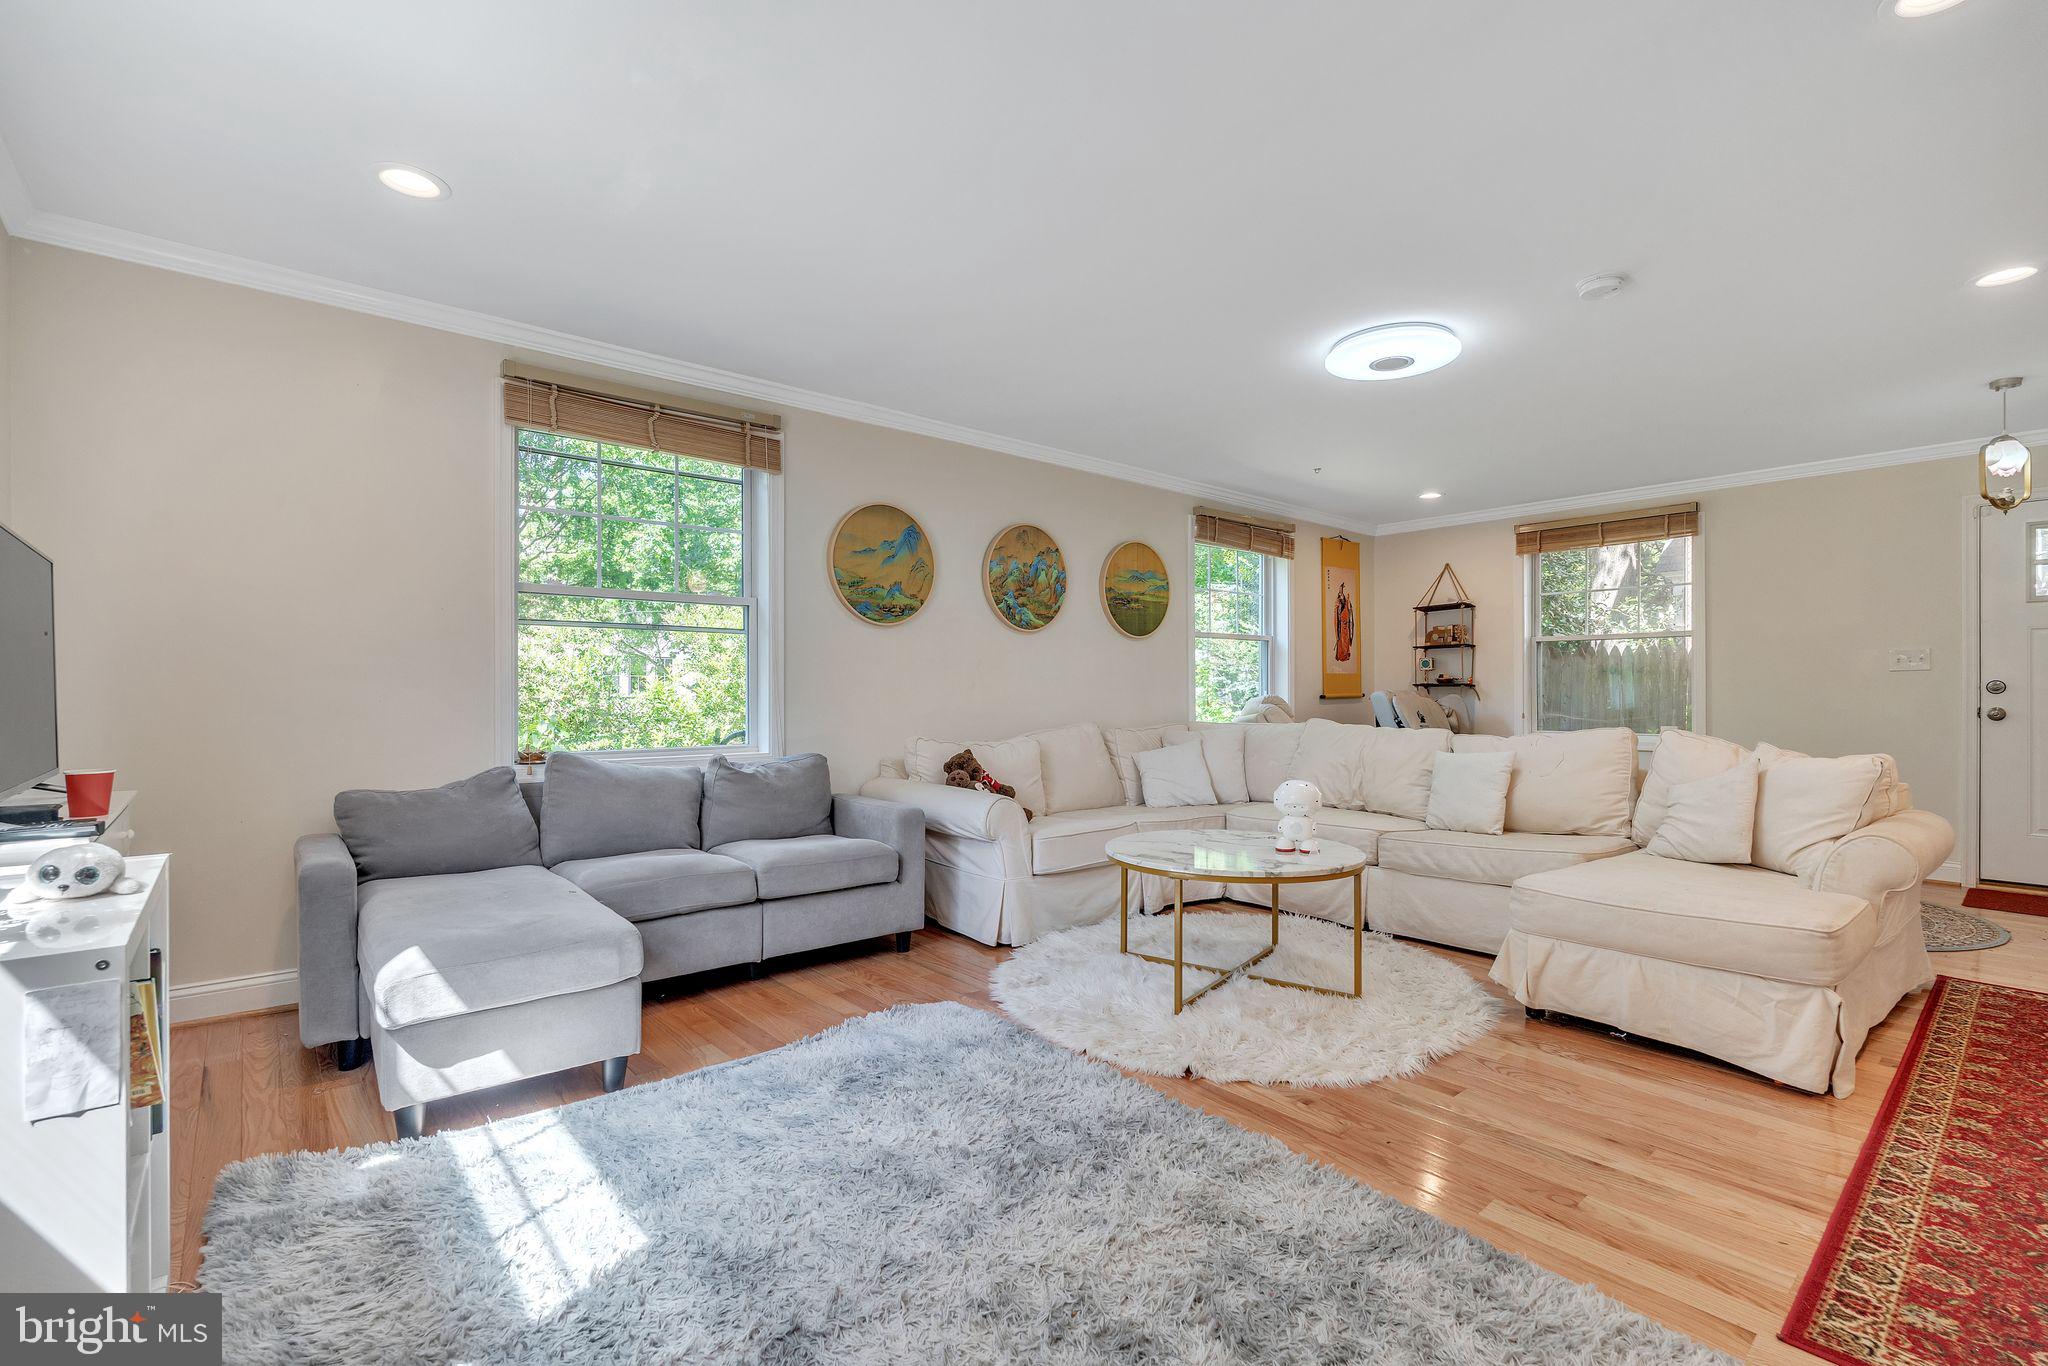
left=170, top=887, right=2048, bottom=1362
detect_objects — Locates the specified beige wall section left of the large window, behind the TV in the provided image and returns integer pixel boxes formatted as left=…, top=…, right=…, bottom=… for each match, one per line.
left=10, top=242, right=504, bottom=983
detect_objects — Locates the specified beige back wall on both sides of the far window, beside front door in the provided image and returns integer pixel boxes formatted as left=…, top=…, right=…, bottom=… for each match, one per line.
left=1372, top=457, right=1976, bottom=821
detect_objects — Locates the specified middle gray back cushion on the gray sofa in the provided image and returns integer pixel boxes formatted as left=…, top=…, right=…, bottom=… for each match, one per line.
left=541, top=754, right=705, bottom=868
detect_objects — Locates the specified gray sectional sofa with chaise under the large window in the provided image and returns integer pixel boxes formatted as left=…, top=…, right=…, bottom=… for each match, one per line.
left=297, top=754, right=926, bottom=1137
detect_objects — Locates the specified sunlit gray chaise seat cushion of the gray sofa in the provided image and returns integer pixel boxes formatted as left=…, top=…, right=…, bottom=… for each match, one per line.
left=356, top=872, right=641, bottom=1030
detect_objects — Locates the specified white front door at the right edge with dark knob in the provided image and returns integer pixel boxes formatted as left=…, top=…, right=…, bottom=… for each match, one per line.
left=1976, top=502, right=2048, bottom=887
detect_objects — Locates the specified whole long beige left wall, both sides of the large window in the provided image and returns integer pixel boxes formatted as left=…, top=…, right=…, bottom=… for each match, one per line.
left=6, top=242, right=1315, bottom=983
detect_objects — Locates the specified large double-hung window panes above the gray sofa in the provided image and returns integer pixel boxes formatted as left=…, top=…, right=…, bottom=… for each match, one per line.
left=514, top=426, right=762, bottom=754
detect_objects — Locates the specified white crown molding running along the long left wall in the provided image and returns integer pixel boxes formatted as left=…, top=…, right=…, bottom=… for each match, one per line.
left=12, top=202, right=1366, bottom=535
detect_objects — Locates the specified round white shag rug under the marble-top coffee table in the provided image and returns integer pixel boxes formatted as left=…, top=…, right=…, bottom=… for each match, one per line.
left=989, top=911, right=1501, bottom=1085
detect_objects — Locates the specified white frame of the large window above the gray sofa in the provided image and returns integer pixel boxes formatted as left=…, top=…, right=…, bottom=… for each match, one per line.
left=494, top=422, right=782, bottom=768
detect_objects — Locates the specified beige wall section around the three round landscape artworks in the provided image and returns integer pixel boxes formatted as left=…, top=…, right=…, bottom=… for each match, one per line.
left=782, top=414, right=1194, bottom=788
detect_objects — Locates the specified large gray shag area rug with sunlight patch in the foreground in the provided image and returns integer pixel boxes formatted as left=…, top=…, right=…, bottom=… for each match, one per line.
left=201, top=1006, right=1726, bottom=1366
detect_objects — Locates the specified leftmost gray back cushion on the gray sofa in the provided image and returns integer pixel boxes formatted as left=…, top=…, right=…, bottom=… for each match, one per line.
left=334, top=768, right=541, bottom=879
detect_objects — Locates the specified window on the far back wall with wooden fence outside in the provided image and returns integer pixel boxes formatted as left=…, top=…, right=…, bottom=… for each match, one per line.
left=1528, top=535, right=1700, bottom=737
